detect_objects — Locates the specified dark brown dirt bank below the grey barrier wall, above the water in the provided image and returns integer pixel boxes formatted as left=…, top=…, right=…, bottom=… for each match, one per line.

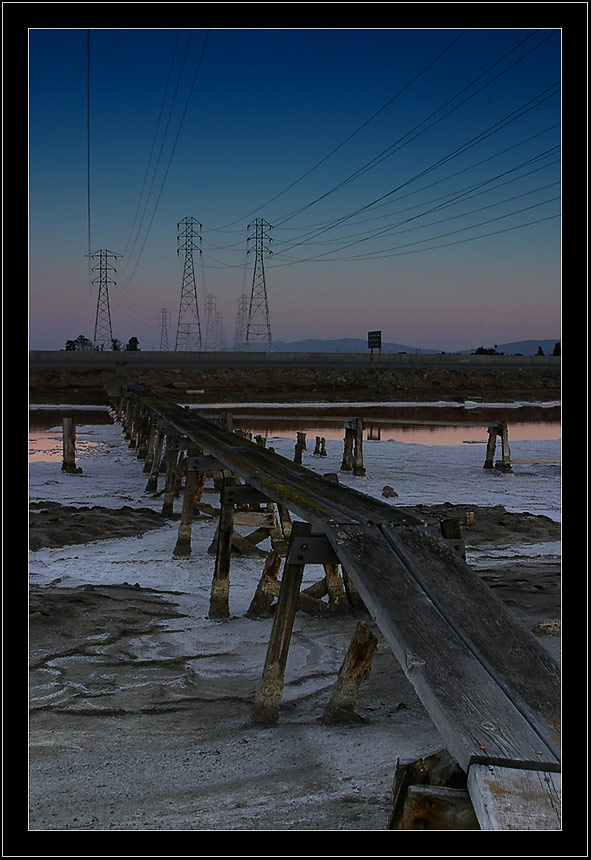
left=29, top=359, right=560, bottom=405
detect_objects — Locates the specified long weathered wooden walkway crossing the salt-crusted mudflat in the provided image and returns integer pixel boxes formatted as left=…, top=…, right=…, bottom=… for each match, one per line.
left=117, top=387, right=560, bottom=830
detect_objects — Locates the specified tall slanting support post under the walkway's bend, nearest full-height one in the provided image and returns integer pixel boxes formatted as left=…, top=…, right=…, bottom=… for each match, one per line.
left=253, top=521, right=312, bottom=725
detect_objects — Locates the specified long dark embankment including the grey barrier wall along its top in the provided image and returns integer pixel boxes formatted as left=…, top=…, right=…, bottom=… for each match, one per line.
left=29, top=352, right=561, bottom=405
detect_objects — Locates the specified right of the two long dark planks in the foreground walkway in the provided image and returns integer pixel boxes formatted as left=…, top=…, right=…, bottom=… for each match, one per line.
left=380, top=525, right=561, bottom=758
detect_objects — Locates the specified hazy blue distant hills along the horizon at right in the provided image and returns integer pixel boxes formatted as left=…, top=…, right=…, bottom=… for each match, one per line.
left=251, top=337, right=560, bottom=355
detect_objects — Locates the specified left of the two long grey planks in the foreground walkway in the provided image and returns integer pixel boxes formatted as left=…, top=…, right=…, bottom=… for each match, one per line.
left=326, top=524, right=558, bottom=771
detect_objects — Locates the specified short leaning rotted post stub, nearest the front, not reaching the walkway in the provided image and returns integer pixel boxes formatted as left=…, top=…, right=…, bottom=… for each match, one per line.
left=322, top=621, right=378, bottom=724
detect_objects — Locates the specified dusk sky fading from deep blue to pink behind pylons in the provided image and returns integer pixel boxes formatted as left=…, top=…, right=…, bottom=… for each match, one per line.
left=28, top=23, right=564, bottom=352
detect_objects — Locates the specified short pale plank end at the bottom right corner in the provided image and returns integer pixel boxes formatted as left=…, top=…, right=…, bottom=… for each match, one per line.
left=468, top=764, right=562, bottom=830
